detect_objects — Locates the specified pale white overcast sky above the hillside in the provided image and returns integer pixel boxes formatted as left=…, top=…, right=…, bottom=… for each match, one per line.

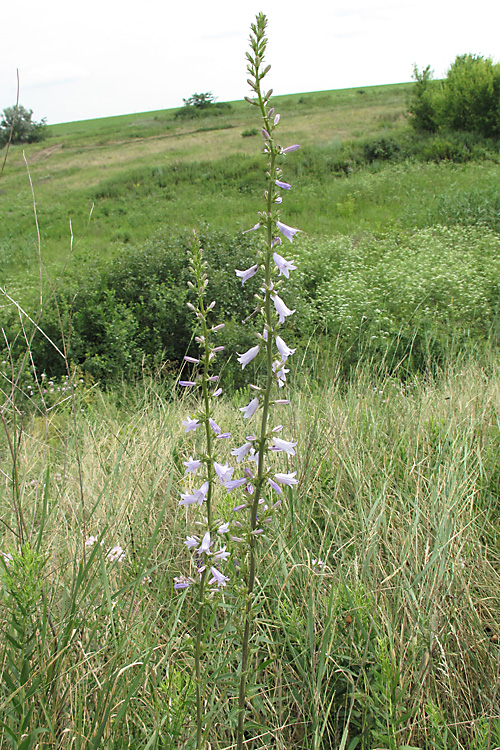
left=0, top=0, right=500, bottom=123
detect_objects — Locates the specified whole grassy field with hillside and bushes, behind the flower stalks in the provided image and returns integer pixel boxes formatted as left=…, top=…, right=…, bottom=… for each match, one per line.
left=0, top=78, right=500, bottom=750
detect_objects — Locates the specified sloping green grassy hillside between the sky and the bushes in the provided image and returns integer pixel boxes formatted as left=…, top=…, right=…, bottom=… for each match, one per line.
left=0, top=84, right=498, bottom=310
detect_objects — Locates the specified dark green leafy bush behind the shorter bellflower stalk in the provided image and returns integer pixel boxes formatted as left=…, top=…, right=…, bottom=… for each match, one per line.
left=1, top=229, right=268, bottom=385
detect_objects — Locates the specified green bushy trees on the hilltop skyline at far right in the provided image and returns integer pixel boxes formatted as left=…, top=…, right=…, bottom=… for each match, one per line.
left=408, top=55, right=500, bottom=138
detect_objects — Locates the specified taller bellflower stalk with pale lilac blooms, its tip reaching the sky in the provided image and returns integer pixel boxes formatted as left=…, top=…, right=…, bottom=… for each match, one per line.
left=232, top=13, right=299, bottom=750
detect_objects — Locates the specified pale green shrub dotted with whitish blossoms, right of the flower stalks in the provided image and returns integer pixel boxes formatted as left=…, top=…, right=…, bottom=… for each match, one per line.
left=314, top=227, right=500, bottom=370
